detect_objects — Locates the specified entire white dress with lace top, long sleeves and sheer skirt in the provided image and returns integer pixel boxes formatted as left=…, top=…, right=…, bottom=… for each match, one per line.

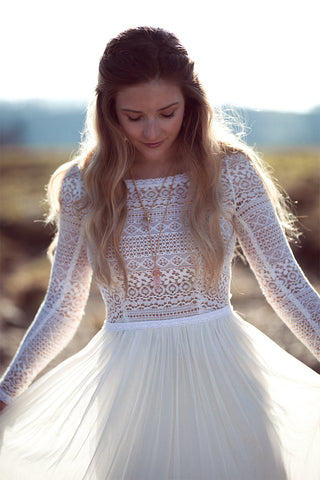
left=0, top=154, right=320, bottom=480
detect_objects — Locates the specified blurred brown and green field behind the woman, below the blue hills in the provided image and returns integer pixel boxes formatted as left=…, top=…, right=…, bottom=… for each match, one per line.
left=0, top=147, right=320, bottom=378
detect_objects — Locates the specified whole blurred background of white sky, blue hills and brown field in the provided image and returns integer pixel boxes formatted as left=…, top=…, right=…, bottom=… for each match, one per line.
left=0, top=0, right=320, bottom=372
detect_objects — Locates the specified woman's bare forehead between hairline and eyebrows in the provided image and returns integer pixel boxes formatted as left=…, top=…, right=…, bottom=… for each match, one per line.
left=116, top=80, right=184, bottom=111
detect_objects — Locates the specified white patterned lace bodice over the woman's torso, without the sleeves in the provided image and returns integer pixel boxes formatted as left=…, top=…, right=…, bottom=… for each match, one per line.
left=102, top=174, right=235, bottom=322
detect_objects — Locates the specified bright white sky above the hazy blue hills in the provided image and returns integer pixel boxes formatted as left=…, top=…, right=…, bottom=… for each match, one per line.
left=0, top=0, right=320, bottom=112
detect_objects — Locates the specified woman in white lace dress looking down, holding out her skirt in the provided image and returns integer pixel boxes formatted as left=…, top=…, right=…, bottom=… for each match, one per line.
left=0, top=28, right=320, bottom=480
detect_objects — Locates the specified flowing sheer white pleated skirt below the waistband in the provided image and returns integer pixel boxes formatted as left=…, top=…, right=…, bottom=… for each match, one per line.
left=0, top=307, right=320, bottom=480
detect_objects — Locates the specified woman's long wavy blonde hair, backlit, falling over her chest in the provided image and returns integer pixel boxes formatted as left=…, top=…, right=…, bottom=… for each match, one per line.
left=48, top=27, right=295, bottom=286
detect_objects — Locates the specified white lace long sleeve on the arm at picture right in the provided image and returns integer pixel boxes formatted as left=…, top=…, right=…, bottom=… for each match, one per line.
left=227, top=154, right=320, bottom=359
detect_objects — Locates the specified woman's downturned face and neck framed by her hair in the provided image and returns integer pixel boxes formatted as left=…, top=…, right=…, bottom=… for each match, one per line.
left=116, top=80, right=185, bottom=167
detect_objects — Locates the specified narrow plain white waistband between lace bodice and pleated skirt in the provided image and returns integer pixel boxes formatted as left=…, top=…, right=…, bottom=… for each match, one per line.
left=104, top=305, right=233, bottom=331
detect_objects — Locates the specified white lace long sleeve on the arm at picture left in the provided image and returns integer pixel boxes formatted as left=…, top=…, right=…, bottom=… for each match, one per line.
left=0, top=163, right=91, bottom=403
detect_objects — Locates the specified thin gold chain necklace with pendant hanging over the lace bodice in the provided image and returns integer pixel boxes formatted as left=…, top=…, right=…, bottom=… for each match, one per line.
left=130, top=172, right=176, bottom=290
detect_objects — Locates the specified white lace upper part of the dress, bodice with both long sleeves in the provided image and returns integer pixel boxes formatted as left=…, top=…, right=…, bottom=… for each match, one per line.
left=0, top=154, right=320, bottom=403
